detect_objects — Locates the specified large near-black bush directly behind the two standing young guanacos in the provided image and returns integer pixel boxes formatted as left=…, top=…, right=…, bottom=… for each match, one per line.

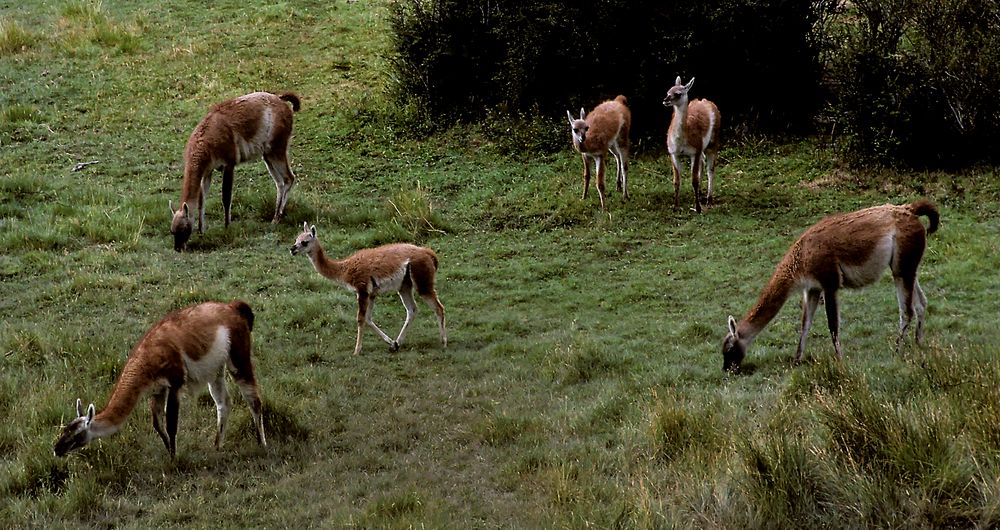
left=392, top=0, right=837, bottom=146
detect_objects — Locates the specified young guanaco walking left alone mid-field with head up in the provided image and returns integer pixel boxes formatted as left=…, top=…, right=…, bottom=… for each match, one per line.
left=290, top=222, right=448, bottom=355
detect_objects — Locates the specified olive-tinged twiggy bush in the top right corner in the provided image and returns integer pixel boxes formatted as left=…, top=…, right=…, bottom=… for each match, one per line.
left=830, top=0, right=1000, bottom=167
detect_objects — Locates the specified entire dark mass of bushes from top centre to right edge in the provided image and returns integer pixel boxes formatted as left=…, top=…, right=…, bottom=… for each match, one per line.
left=392, top=0, right=1000, bottom=166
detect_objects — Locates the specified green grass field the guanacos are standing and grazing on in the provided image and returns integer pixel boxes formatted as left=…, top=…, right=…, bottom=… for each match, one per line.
left=0, top=0, right=1000, bottom=528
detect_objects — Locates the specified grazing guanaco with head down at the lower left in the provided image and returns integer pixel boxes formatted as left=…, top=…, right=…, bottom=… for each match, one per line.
left=54, top=300, right=267, bottom=458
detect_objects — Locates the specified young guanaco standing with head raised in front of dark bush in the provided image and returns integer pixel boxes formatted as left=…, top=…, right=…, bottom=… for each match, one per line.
left=663, top=76, right=722, bottom=213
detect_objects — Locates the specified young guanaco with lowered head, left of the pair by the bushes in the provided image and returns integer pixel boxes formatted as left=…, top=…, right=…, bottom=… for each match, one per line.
left=566, top=96, right=632, bottom=210
